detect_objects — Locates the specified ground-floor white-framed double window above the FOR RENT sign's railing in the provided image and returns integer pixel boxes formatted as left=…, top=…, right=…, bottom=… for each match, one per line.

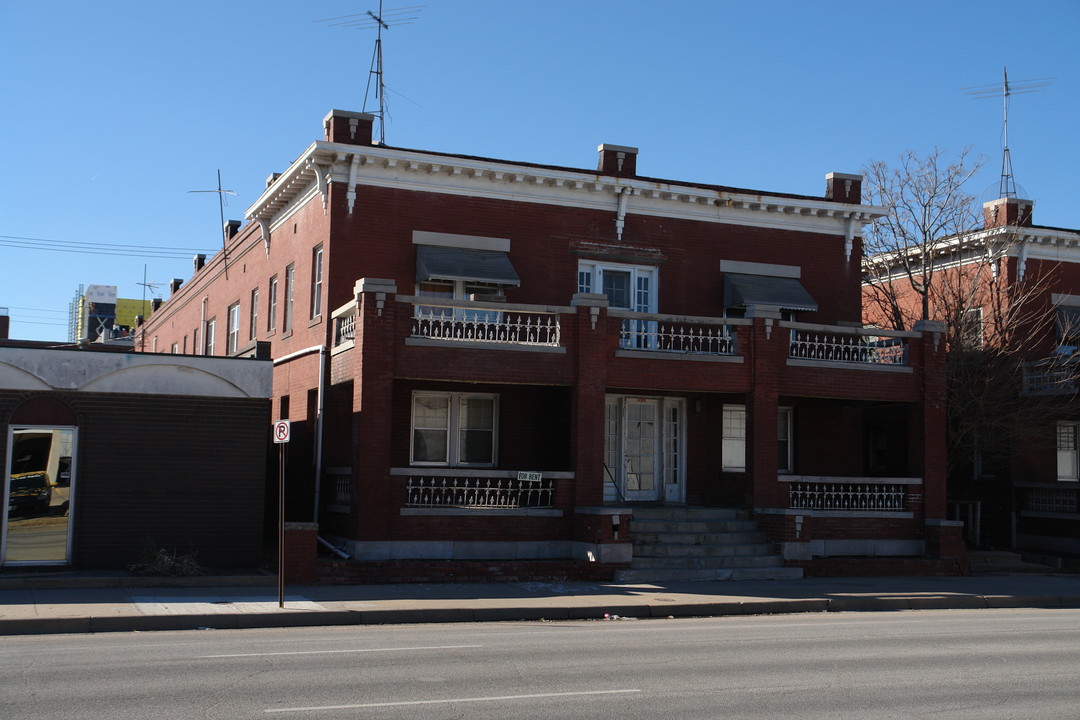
left=410, top=392, right=499, bottom=467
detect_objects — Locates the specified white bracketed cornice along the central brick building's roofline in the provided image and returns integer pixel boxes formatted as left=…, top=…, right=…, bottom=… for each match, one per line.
left=246, top=141, right=882, bottom=235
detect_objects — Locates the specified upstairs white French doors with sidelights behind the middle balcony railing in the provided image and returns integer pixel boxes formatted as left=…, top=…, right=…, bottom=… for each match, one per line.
left=578, top=260, right=657, bottom=349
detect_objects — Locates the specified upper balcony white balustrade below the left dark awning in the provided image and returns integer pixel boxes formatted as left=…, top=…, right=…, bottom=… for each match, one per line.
left=411, top=304, right=562, bottom=348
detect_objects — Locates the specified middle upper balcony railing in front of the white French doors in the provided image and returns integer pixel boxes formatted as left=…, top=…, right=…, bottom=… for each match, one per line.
left=610, top=310, right=748, bottom=355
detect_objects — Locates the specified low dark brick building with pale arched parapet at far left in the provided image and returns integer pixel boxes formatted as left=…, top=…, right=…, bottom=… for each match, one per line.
left=0, top=341, right=271, bottom=570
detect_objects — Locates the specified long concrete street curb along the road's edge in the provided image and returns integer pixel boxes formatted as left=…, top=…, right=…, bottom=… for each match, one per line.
left=0, top=595, right=1080, bottom=636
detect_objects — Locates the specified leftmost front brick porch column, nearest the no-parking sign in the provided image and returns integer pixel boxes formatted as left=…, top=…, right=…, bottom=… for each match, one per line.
left=352, top=277, right=400, bottom=540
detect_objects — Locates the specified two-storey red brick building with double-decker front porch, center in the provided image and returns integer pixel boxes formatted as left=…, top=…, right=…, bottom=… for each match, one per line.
left=137, top=110, right=960, bottom=576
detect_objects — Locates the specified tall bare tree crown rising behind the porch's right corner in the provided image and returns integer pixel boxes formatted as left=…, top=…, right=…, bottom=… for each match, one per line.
left=863, top=149, right=985, bottom=330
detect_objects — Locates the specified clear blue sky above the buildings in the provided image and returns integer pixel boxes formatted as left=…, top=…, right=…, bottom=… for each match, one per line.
left=0, top=0, right=1080, bottom=341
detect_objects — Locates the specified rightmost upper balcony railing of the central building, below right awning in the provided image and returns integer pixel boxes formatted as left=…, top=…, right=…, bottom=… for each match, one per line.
left=780, top=323, right=919, bottom=366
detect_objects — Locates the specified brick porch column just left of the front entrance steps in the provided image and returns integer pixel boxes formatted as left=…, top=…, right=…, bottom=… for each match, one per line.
left=570, top=293, right=611, bottom=507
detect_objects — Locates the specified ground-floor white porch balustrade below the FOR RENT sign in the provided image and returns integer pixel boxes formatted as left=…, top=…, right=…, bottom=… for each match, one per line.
left=405, top=474, right=555, bottom=508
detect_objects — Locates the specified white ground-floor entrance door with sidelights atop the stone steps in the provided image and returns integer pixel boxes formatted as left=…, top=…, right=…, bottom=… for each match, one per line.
left=604, top=395, right=686, bottom=503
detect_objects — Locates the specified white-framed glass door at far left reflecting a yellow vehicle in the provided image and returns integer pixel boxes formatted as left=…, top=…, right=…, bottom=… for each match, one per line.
left=0, top=425, right=78, bottom=565
